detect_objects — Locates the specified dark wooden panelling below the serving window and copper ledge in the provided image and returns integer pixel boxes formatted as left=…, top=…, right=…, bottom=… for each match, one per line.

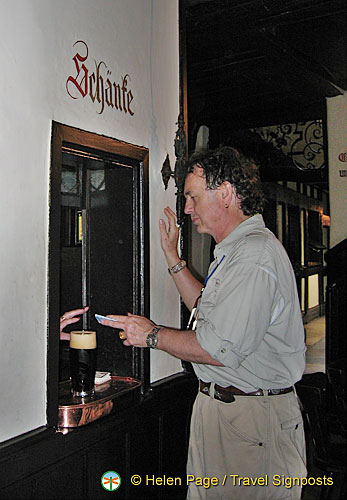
left=0, top=373, right=197, bottom=500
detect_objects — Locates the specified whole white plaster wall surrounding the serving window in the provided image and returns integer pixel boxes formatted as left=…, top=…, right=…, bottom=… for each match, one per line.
left=0, top=0, right=181, bottom=441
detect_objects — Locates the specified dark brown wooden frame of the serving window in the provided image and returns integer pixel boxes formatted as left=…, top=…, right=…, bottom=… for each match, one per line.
left=47, top=122, right=150, bottom=427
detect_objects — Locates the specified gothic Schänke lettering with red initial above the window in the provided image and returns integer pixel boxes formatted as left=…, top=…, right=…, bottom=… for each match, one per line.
left=66, top=40, right=134, bottom=116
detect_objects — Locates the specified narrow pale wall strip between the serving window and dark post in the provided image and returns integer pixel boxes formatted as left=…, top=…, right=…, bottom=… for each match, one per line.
left=146, top=0, right=186, bottom=381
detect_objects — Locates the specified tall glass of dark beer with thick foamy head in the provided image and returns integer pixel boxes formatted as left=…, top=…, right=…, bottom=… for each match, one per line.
left=70, top=330, right=96, bottom=398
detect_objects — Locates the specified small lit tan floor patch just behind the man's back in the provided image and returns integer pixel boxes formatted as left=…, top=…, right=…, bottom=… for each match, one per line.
left=305, top=316, right=325, bottom=373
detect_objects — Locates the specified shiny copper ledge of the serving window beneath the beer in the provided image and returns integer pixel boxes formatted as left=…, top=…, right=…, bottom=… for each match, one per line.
left=58, top=376, right=141, bottom=434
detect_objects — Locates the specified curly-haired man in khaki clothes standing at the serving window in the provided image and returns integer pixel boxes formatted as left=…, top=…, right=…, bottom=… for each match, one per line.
left=103, top=147, right=306, bottom=500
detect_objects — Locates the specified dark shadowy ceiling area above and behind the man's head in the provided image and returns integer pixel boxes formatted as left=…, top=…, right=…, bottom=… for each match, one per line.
left=184, top=0, right=347, bottom=189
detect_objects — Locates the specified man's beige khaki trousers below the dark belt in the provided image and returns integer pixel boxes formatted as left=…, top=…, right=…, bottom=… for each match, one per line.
left=187, top=390, right=307, bottom=500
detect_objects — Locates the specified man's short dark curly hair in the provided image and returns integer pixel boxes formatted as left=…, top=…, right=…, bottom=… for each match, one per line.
left=186, top=146, right=265, bottom=215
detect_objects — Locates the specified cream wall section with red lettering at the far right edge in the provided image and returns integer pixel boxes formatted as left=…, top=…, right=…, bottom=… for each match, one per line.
left=327, top=93, right=347, bottom=248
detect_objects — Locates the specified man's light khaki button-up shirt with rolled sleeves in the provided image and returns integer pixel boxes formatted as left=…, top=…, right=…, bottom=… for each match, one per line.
left=193, top=215, right=306, bottom=392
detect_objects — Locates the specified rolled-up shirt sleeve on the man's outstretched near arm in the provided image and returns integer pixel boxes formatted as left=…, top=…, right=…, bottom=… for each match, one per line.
left=196, top=262, right=276, bottom=369
